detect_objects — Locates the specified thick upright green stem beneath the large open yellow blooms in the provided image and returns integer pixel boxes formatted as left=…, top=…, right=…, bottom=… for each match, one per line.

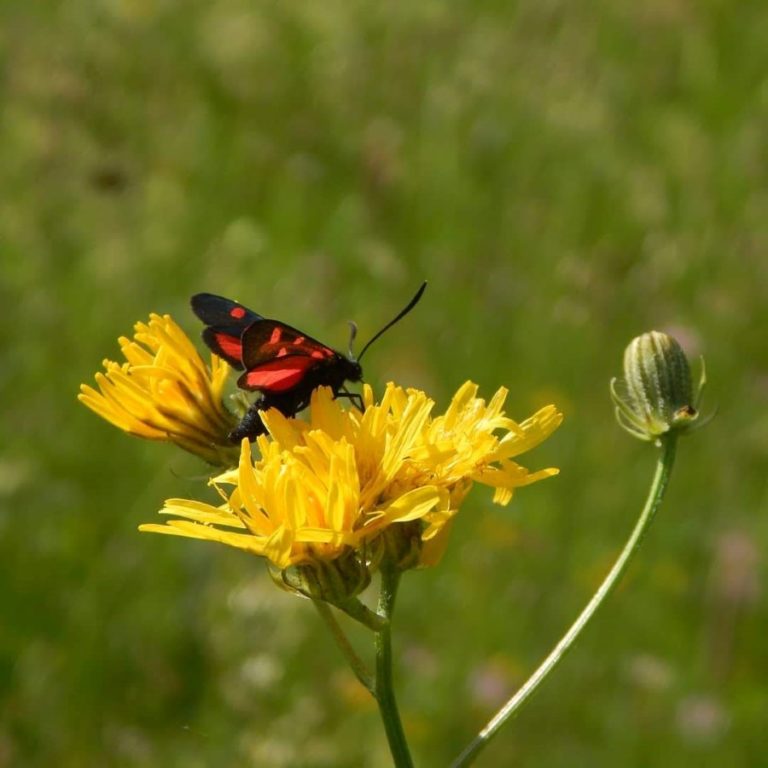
left=376, top=564, right=413, bottom=768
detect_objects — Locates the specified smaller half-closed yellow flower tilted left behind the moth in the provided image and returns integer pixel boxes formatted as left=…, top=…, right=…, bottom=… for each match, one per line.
left=78, top=314, right=238, bottom=466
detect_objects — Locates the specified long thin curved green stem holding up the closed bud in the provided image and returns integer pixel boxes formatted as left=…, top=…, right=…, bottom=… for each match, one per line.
left=452, top=435, right=676, bottom=768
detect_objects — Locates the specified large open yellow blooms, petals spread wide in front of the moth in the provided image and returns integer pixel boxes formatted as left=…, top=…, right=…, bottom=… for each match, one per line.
left=141, top=382, right=562, bottom=583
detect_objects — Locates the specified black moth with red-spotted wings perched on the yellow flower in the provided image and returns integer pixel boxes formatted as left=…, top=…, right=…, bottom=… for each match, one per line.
left=190, top=283, right=427, bottom=443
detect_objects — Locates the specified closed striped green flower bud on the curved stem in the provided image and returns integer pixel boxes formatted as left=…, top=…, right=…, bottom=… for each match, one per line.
left=611, top=331, right=705, bottom=442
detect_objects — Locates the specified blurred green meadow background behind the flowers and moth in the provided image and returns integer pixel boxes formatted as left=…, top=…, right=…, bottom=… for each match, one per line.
left=0, top=0, right=768, bottom=768
